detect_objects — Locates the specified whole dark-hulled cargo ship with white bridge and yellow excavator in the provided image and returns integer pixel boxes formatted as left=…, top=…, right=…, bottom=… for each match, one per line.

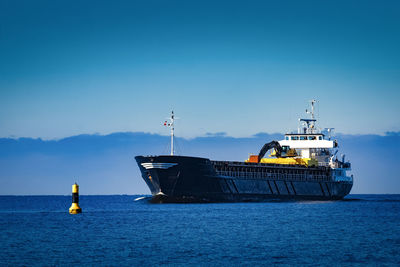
left=135, top=100, right=353, bottom=203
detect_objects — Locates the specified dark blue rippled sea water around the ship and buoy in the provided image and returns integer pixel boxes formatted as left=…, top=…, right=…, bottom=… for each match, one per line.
left=0, top=195, right=400, bottom=266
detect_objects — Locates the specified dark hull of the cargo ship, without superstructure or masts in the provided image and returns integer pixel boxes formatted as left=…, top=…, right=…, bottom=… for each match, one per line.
left=135, top=156, right=353, bottom=203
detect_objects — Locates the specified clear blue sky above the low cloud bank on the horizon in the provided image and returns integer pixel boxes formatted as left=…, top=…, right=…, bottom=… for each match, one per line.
left=0, top=0, right=400, bottom=139
